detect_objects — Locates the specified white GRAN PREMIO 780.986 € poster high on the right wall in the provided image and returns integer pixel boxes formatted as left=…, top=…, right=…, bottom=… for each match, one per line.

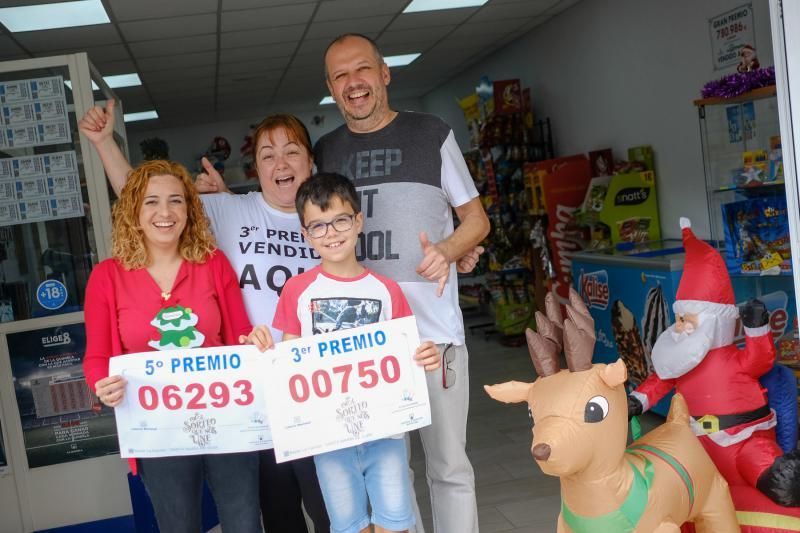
left=708, top=4, right=756, bottom=70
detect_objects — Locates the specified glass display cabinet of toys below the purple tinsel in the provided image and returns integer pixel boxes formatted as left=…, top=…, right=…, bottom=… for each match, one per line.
left=694, top=86, right=800, bottom=368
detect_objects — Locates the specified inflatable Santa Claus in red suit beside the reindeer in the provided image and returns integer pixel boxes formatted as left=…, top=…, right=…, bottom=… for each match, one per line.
left=628, top=219, right=800, bottom=506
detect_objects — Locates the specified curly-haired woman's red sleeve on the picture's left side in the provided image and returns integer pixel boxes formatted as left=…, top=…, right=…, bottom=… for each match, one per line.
left=83, top=262, right=117, bottom=392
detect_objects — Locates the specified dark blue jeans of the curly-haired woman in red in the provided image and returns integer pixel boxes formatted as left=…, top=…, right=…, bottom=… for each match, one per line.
left=137, top=452, right=261, bottom=533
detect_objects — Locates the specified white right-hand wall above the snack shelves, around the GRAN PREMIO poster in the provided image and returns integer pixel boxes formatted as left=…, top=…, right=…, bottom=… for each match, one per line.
left=423, top=0, right=773, bottom=237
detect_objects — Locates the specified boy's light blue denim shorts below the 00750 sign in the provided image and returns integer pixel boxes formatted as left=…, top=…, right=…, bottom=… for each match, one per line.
left=312, top=438, right=414, bottom=533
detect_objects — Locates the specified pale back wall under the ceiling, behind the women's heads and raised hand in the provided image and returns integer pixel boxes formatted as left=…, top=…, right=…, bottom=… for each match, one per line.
left=123, top=99, right=422, bottom=184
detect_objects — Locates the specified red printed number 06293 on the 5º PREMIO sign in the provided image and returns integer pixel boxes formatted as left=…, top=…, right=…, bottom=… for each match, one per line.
left=139, top=379, right=255, bottom=411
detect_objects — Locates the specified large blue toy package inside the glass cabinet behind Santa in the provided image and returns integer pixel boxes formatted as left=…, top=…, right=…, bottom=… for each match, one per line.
left=722, top=195, right=792, bottom=275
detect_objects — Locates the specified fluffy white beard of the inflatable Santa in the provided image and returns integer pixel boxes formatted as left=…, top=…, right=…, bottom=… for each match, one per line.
left=652, top=315, right=730, bottom=379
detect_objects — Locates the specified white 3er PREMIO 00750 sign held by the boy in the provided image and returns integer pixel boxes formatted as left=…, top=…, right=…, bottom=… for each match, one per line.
left=266, top=317, right=431, bottom=462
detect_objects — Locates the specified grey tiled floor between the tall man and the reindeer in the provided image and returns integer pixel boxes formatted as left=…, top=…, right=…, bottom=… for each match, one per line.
left=411, top=312, right=663, bottom=533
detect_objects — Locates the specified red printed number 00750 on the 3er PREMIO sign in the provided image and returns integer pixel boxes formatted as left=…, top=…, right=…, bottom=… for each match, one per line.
left=289, top=355, right=400, bottom=403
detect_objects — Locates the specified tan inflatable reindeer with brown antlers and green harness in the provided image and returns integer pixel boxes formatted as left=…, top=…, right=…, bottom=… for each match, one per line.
left=485, top=290, right=739, bottom=533
